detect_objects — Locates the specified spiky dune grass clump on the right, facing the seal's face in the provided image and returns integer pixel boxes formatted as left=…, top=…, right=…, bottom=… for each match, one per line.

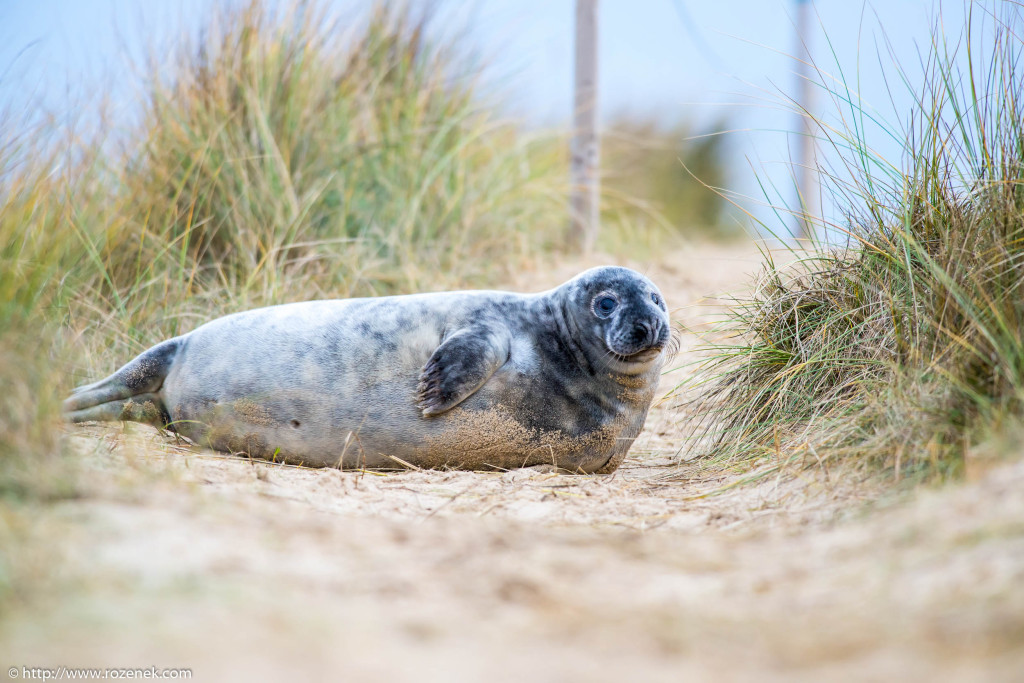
left=690, top=5, right=1024, bottom=480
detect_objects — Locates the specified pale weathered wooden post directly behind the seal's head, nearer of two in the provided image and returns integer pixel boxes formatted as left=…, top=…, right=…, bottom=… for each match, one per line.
left=569, top=0, right=600, bottom=253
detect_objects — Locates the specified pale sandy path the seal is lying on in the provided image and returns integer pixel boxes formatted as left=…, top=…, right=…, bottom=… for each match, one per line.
left=0, top=242, right=1024, bottom=681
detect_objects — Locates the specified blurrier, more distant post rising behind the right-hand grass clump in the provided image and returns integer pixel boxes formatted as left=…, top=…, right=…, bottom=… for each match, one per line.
left=796, top=0, right=821, bottom=239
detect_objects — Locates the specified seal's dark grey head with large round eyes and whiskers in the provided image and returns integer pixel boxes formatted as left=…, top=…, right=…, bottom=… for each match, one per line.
left=563, top=266, right=672, bottom=374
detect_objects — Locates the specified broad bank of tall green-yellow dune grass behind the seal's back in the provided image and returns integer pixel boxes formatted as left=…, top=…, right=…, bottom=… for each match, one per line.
left=0, top=0, right=566, bottom=354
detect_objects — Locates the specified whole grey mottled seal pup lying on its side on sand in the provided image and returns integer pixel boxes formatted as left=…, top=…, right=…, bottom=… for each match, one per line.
left=63, top=266, right=675, bottom=473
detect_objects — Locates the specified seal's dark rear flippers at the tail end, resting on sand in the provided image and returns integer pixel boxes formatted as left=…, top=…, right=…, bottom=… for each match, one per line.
left=63, top=337, right=183, bottom=424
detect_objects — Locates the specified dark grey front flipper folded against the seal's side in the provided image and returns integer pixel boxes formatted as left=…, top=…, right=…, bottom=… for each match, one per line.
left=418, top=328, right=509, bottom=418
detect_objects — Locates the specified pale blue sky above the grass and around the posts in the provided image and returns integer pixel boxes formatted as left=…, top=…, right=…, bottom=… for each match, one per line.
left=0, top=0, right=974, bottom=239
